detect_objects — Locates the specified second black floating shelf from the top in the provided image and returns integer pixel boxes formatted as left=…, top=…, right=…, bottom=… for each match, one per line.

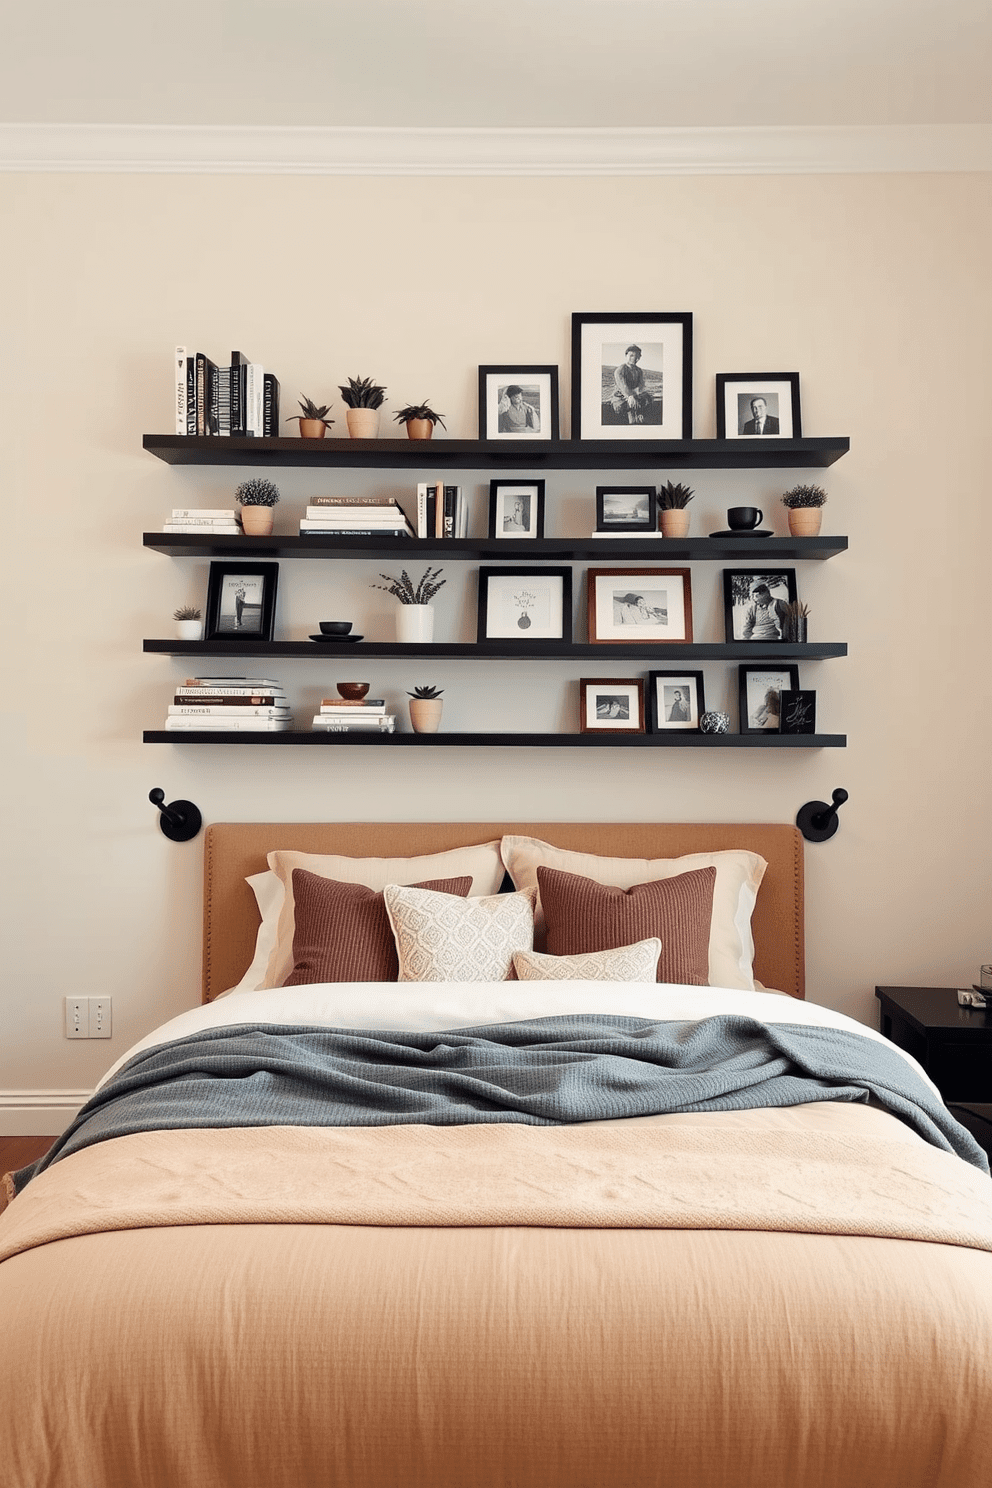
left=141, top=533, right=848, bottom=562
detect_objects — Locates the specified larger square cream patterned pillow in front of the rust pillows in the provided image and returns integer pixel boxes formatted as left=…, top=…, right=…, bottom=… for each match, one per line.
left=382, top=884, right=534, bottom=982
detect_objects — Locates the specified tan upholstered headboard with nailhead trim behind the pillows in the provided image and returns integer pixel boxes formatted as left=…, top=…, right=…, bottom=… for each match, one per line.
left=204, top=821, right=805, bottom=1003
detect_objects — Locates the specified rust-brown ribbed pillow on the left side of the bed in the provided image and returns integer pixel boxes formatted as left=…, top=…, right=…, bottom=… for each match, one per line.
left=283, top=868, right=471, bottom=987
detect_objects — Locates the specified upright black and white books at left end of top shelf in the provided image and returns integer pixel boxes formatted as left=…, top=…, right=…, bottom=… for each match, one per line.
left=173, top=347, right=280, bottom=439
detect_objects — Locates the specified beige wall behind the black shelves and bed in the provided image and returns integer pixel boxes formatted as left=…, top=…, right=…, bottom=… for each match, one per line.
left=0, top=176, right=992, bottom=1129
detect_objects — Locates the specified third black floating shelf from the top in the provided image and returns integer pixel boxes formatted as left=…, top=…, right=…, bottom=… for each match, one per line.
left=143, top=640, right=848, bottom=665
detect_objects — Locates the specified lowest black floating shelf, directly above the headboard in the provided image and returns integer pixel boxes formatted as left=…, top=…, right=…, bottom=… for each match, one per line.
left=143, top=729, right=848, bottom=748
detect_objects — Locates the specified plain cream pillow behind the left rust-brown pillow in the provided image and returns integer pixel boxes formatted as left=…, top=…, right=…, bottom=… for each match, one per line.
left=262, top=841, right=503, bottom=987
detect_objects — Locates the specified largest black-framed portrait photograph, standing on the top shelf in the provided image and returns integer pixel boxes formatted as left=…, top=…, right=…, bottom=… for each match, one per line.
left=571, top=311, right=693, bottom=439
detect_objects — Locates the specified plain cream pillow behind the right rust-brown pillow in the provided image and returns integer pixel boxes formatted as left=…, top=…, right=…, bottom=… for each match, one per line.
left=500, top=836, right=767, bottom=992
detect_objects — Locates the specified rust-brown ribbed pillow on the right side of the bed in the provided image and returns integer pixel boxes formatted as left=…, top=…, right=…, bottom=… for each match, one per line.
left=537, top=868, right=717, bottom=987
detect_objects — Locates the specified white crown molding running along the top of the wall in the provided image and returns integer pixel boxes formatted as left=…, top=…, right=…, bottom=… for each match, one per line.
left=0, top=124, right=992, bottom=176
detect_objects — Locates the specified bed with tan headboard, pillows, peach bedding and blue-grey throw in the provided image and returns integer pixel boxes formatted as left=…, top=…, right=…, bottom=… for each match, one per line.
left=0, top=823, right=992, bottom=1488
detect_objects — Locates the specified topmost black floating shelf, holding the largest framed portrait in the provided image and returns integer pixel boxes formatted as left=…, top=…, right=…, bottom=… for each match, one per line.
left=143, top=434, right=851, bottom=470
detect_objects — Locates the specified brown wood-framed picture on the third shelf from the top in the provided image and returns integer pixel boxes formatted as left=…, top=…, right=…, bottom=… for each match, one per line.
left=587, top=568, right=693, bottom=646
